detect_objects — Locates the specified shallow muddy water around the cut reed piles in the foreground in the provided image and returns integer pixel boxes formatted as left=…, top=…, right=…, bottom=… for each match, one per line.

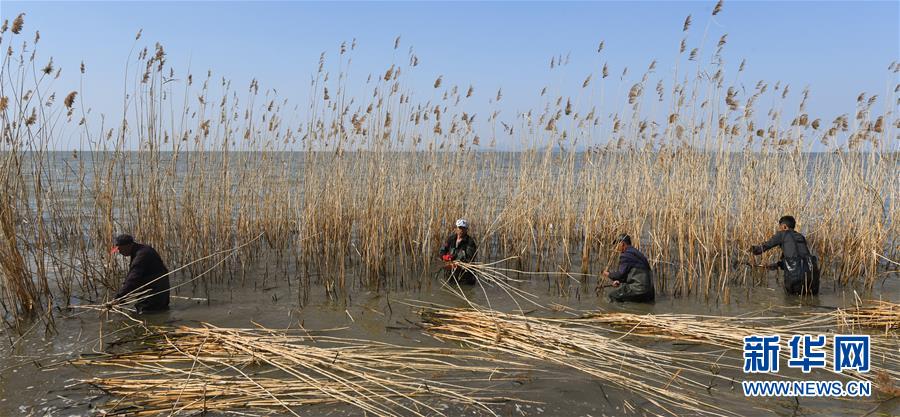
left=0, top=258, right=900, bottom=417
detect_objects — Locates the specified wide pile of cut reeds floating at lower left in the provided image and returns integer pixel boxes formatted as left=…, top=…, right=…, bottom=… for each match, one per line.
left=74, top=324, right=524, bottom=416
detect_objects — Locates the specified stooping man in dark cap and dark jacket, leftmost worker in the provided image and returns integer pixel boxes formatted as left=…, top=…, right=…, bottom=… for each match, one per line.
left=112, top=235, right=169, bottom=313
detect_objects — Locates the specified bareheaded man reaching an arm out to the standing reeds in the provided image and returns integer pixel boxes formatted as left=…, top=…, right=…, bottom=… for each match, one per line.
left=750, top=216, right=819, bottom=295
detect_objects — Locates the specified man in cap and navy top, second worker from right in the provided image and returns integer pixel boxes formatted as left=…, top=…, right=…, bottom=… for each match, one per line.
left=603, top=234, right=656, bottom=303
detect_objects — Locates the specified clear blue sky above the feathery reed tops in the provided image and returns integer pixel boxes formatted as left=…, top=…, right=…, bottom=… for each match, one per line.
left=0, top=1, right=900, bottom=150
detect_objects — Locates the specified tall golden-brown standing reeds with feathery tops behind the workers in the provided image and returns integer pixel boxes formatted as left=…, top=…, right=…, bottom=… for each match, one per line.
left=0, top=7, right=900, bottom=326
